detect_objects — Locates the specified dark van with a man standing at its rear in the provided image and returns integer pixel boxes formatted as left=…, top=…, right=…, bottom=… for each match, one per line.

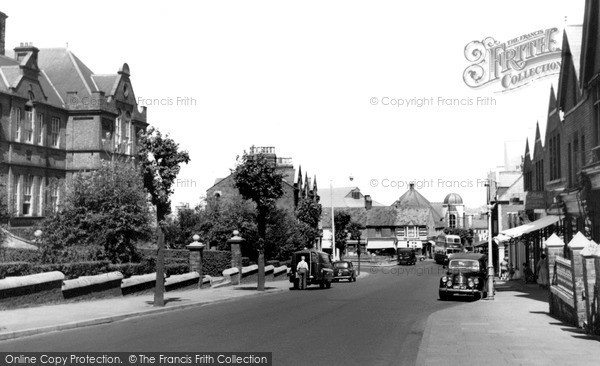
left=288, top=249, right=333, bottom=289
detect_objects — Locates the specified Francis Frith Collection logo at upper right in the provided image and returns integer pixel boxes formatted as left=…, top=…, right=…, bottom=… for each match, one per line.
left=463, top=28, right=561, bottom=92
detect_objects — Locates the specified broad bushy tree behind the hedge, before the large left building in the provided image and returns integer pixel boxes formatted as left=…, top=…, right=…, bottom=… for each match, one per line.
left=41, top=161, right=150, bottom=263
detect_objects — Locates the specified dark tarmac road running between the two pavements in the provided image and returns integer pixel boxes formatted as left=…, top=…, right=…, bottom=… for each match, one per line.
left=0, top=261, right=460, bottom=365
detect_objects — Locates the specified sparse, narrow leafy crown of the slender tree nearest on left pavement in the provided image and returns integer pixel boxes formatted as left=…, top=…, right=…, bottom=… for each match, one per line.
left=138, top=127, right=190, bottom=224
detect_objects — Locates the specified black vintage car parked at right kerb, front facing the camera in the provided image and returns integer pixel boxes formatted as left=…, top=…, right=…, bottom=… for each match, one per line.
left=439, top=253, right=487, bottom=300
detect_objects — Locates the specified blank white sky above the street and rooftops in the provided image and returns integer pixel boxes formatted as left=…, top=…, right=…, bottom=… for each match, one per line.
left=0, top=0, right=584, bottom=207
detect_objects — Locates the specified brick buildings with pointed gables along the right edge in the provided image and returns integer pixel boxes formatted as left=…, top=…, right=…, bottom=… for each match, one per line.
left=522, top=0, right=600, bottom=261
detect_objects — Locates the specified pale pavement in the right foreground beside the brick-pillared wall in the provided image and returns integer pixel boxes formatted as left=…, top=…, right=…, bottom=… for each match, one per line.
left=417, top=280, right=600, bottom=366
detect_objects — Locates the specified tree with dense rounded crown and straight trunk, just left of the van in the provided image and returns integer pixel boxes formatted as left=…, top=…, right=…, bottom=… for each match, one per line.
left=232, top=147, right=283, bottom=291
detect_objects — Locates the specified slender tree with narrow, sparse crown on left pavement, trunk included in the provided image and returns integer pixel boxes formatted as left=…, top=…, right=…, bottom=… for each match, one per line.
left=138, top=128, right=190, bottom=306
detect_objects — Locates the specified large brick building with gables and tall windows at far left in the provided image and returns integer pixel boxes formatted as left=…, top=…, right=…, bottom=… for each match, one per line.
left=0, top=12, right=147, bottom=227
